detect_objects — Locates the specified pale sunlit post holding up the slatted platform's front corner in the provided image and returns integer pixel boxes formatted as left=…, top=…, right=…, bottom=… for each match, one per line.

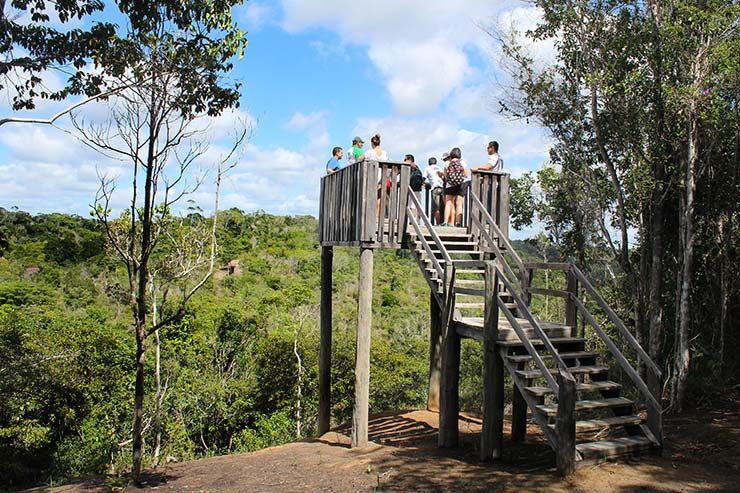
left=352, top=246, right=373, bottom=448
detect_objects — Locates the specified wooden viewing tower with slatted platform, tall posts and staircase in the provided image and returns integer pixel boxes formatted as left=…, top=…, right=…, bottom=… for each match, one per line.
left=318, top=161, right=663, bottom=474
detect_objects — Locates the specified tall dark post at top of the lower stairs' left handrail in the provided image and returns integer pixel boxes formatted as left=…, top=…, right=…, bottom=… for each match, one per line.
left=481, top=261, right=504, bottom=461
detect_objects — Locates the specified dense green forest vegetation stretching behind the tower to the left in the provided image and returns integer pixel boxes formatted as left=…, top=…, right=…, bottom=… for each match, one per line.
left=0, top=209, right=446, bottom=486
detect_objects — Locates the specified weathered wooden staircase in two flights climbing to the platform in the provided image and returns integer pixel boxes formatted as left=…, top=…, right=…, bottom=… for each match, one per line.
left=407, top=212, right=662, bottom=470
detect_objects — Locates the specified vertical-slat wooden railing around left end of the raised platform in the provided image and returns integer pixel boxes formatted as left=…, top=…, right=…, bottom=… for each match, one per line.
left=319, top=161, right=410, bottom=248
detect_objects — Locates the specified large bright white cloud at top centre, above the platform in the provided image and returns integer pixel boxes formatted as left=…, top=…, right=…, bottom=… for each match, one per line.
left=282, top=0, right=503, bottom=115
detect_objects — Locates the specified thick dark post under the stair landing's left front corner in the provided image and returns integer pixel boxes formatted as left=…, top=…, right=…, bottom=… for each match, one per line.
left=438, top=298, right=460, bottom=448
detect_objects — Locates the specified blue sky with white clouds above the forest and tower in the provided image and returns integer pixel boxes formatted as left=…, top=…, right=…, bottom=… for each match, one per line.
left=0, top=0, right=552, bottom=233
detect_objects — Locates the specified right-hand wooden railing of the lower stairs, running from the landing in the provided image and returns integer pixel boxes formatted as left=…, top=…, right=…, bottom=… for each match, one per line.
left=523, top=263, right=663, bottom=444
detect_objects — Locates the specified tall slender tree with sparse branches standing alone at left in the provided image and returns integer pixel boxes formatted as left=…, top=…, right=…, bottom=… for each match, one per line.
left=68, top=0, right=246, bottom=481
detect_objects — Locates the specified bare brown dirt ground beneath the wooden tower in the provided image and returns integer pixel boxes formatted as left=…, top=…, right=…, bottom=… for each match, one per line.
left=23, top=395, right=740, bottom=493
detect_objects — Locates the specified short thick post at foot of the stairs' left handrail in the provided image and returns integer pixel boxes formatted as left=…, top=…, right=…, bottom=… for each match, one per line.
left=555, top=370, right=576, bottom=476
